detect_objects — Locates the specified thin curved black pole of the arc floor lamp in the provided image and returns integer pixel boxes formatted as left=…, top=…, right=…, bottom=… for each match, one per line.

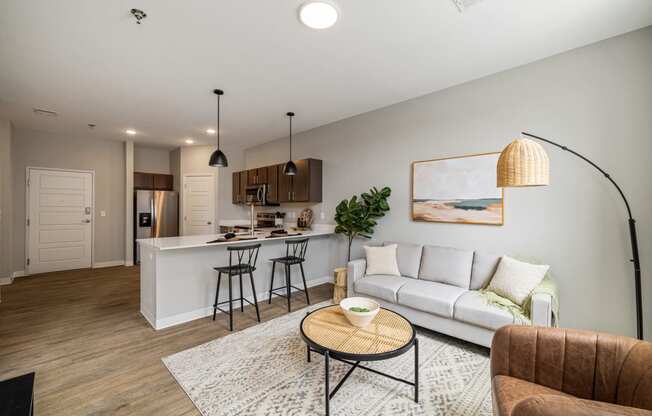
left=521, top=132, right=643, bottom=339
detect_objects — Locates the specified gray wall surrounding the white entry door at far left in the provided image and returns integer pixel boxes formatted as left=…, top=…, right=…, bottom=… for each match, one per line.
left=12, top=129, right=125, bottom=270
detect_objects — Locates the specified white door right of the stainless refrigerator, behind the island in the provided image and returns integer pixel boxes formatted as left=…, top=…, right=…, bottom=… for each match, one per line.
left=183, top=175, right=216, bottom=235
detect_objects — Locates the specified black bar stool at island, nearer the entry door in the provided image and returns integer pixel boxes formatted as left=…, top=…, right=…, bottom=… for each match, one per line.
left=213, top=244, right=260, bottom=331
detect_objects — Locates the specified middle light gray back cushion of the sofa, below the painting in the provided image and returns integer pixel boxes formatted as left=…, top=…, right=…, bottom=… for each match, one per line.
left=419, top=246, right=473, bottom=289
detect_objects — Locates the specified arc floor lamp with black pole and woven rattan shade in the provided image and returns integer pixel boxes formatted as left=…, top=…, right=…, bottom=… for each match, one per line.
left=497, top=132, right=643, bottom=339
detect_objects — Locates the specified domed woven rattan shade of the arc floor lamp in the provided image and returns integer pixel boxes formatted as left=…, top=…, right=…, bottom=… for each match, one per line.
left=497, top=139, right=550, bottom=188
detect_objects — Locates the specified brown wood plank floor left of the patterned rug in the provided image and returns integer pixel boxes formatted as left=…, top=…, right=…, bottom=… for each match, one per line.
left=0, top=267, right=332, bottom=416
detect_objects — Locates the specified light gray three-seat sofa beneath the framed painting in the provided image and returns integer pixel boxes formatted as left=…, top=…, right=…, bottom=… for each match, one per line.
left=347, top=242, right=552, bottom=347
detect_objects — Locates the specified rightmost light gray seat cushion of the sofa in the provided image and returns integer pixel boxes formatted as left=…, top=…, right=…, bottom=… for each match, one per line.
left=453, top=290, right=514, bottom=331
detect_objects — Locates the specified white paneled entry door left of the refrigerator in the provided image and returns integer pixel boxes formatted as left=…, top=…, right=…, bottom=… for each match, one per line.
left=27, top=168, right=93, bottom=274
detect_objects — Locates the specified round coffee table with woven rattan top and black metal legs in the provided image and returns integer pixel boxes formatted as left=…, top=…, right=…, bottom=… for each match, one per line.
left=300, top=305, right=419, bottom=415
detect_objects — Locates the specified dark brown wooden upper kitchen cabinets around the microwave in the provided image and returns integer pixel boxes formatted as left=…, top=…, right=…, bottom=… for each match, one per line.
left=233, top=159, right=322, bottom=204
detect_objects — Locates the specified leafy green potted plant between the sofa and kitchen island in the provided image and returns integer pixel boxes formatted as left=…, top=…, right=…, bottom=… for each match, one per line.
left=333, top=187, right=392, bottom=303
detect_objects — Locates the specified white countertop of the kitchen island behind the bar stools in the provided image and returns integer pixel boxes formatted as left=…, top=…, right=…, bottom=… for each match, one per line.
left=136, top=224, right=335, bottom=250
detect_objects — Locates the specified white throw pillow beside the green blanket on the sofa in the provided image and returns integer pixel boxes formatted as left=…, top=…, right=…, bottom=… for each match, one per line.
left=487, top=256, right=550, bottom=306
